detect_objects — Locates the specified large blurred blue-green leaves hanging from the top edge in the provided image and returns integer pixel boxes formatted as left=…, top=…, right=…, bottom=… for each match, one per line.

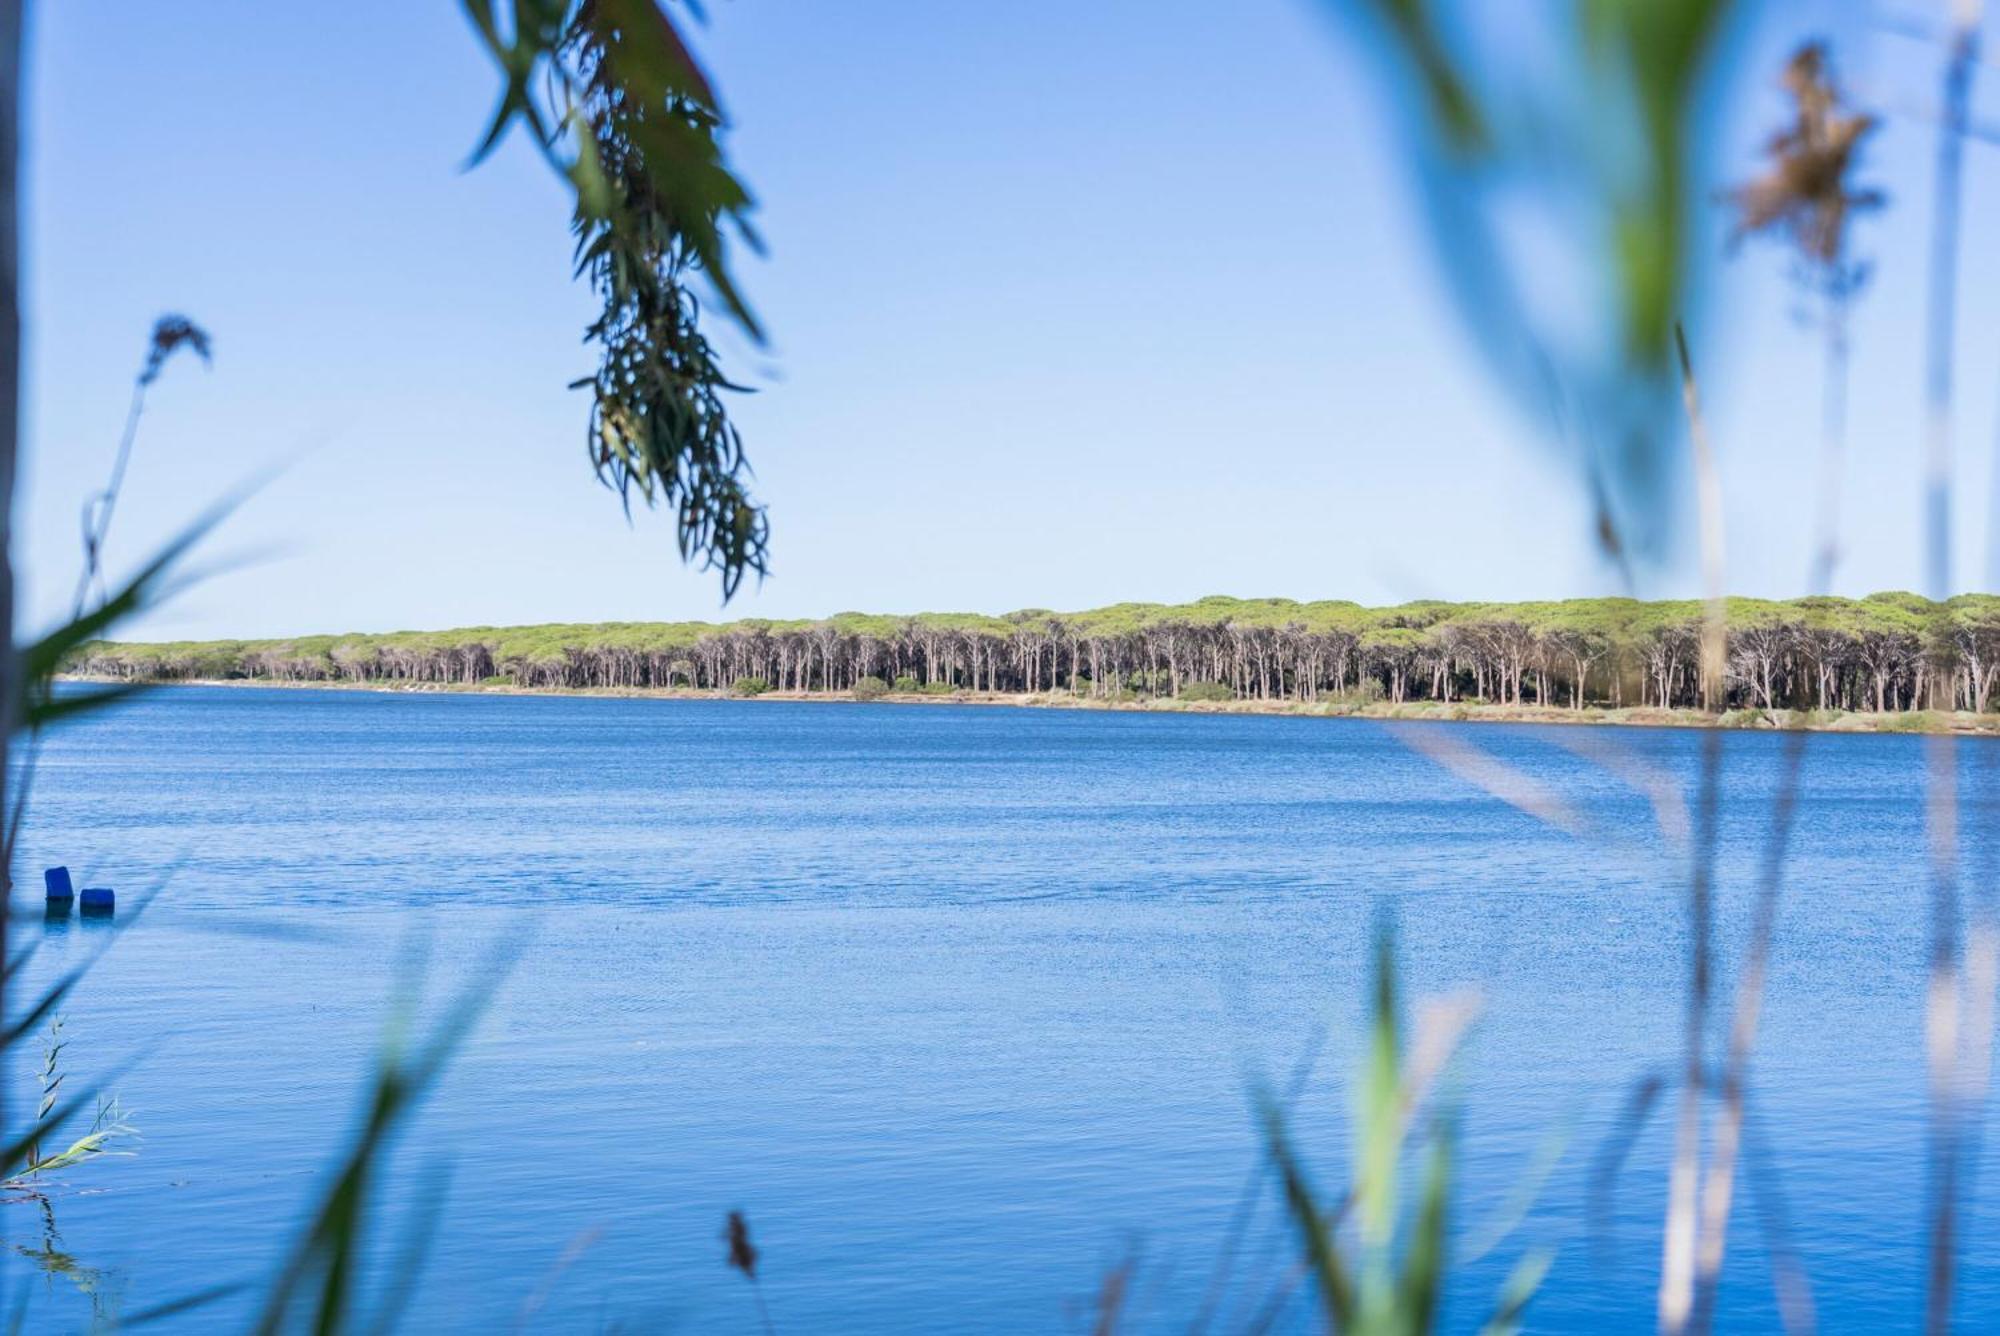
left=1338, top=0, right=1742, bottom=558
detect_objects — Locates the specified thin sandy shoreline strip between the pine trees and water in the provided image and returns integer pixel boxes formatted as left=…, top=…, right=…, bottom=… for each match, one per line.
left=58, top=674, right=2000, bottom=738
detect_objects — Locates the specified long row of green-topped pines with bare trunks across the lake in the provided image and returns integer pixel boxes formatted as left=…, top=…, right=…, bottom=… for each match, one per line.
left=70, top=594, right=2000, bottom=712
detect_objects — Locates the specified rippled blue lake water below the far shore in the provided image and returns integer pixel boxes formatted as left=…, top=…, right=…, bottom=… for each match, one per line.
left=11, top=688, right=2000, bottom=1332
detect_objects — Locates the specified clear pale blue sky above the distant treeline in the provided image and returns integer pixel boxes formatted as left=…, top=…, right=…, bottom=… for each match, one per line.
left=18, top=0, right=2000, bottom=638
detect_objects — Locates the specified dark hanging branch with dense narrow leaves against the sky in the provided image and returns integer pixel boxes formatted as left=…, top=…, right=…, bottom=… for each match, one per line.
left=466, top=0, right=770, bottom=600
